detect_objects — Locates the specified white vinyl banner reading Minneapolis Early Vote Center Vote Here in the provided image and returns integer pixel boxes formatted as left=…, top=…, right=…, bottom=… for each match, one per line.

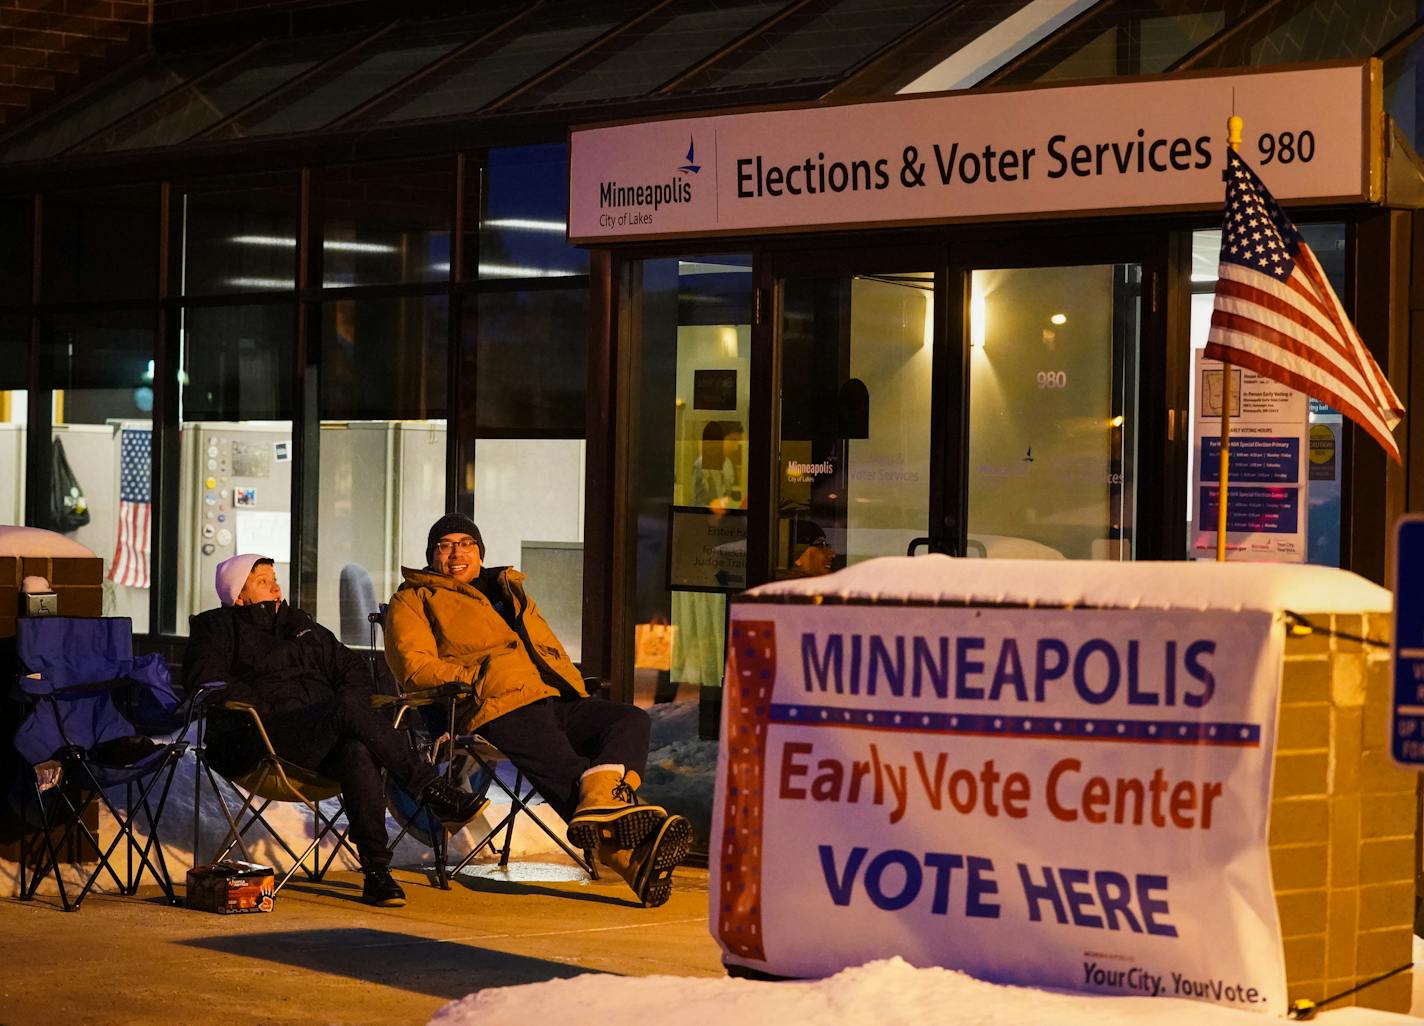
left=709, top=601, right=1286, bottom=1013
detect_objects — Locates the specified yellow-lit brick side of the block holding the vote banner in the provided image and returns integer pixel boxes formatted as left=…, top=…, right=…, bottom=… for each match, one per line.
left=1270, top=613, right=1417, bottom=1012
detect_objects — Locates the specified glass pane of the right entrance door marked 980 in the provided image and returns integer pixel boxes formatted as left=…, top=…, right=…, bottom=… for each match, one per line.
left=967, top=265, right=1141, bottom=559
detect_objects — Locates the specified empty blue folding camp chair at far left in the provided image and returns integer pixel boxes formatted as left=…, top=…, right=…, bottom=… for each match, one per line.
left=14, top=616, right=187, bottom=912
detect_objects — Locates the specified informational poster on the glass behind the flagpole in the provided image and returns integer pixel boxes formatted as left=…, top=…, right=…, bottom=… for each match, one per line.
left=1192, top=350, right=1310, bottom=564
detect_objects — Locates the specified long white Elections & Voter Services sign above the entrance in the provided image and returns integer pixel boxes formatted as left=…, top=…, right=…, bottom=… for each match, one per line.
left=568, top=63, right=1380, bottom=242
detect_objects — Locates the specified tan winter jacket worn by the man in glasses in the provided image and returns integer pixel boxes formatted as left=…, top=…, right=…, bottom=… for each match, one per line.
left=386, top=566, right=588, bottom=730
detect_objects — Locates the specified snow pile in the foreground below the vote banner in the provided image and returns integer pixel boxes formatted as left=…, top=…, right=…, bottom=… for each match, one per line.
left=430, top=958, right=1417, bottom=1026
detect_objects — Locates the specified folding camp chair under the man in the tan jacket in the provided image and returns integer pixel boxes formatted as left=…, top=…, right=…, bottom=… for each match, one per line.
left=367, top=603, right=598, bottom=889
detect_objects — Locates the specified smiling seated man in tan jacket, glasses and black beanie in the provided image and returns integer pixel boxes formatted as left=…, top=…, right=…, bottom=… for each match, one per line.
left=386, top=514, right=692, bottom=908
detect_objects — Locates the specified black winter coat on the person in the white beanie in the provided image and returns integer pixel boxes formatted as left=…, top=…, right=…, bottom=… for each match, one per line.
left=182, top=602, right=373, bottom=713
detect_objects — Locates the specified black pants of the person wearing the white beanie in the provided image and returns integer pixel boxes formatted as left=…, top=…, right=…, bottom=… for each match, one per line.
left=208, top=692, right=439, bottom=868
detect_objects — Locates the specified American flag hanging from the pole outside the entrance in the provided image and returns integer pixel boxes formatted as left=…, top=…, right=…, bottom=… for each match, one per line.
left=1205, top=149, right=1404, bottom=462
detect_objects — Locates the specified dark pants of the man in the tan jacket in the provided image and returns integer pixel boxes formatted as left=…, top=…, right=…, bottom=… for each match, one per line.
left=480, top=699, right=652, bottom=821
